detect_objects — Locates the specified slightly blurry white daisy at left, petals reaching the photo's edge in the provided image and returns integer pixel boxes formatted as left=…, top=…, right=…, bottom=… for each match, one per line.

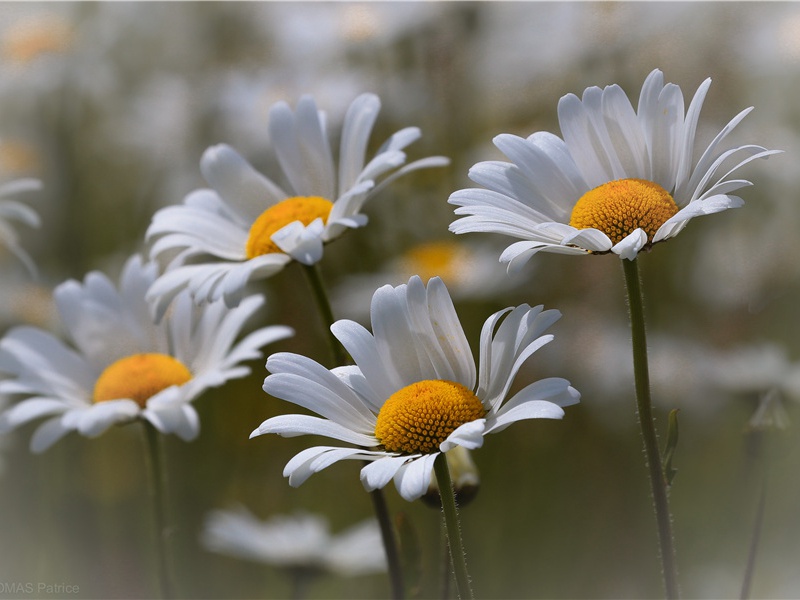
left=0, top=255, right=292, bottom=452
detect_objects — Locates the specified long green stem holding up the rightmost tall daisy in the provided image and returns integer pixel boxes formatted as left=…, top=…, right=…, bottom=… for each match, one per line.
left=622, top=259, right=679, bottom=599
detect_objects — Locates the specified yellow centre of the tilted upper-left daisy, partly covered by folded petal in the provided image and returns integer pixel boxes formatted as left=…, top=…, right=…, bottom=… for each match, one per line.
left=246, top=196, right=333, bottom=258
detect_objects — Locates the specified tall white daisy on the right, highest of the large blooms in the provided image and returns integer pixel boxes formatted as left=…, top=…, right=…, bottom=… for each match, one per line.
left=448, top=69, right=777, bottom=271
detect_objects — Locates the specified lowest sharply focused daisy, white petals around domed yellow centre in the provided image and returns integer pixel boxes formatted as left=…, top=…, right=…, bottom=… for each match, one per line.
left=251, top=276, right=580, bottom=500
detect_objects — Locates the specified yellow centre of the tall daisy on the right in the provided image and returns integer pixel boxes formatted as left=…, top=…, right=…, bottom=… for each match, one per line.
left=569, top=179, right=678, bottom=244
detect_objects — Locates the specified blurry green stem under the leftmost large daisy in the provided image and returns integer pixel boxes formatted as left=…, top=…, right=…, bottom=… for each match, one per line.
left=143, top=421, right=173, bottom=598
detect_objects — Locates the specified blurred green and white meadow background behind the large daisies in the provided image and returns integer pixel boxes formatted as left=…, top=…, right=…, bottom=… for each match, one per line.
left=0, top=2, right=800, bottom=598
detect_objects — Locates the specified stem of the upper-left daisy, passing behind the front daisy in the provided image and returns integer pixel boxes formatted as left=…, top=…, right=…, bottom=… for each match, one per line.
left=296, top=265, right=405, bottom=600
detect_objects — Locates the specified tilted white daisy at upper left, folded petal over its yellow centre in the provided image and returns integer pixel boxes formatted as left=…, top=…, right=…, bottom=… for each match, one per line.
left=147, top=94, right=448, bottom=314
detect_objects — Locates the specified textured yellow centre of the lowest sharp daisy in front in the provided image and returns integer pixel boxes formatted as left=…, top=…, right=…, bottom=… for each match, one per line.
left=375, top=380, right=486, bottom=454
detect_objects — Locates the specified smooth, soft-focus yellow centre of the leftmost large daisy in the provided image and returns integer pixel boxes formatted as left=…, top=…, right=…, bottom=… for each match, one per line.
left=92, top=352, right=192, bottom=408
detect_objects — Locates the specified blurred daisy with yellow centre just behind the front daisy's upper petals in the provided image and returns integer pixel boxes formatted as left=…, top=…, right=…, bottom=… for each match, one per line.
left=332, top=239, right=522, bottom=320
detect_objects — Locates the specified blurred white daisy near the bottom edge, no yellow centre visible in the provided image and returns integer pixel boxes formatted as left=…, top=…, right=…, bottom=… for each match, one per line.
left=201, top=507, right=386, bottom=576
